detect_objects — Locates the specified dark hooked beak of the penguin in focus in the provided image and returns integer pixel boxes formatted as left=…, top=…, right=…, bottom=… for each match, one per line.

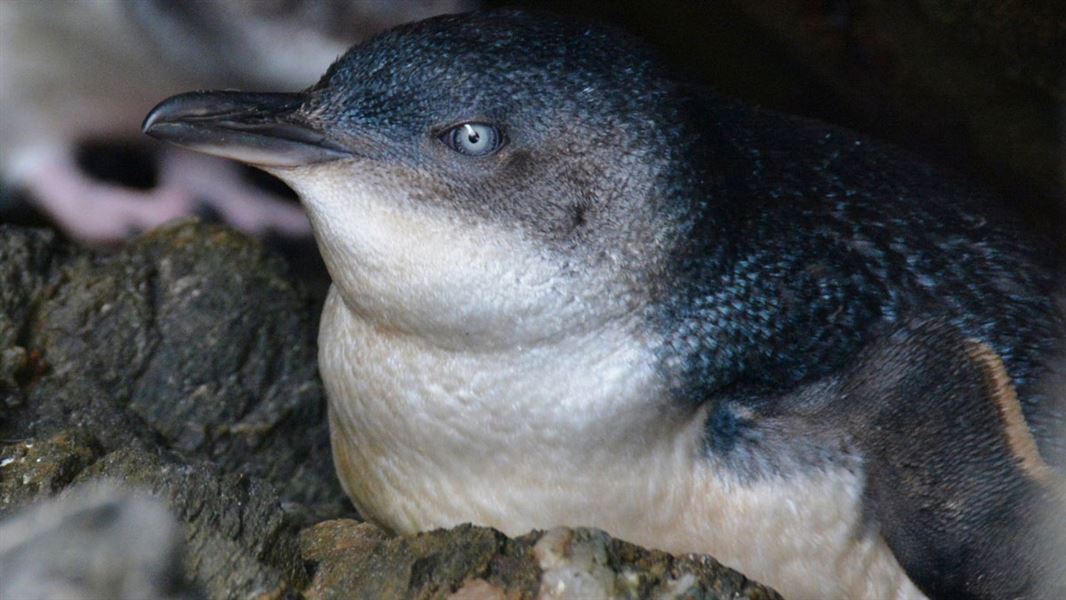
left=141, top=92, right=352, bottom=167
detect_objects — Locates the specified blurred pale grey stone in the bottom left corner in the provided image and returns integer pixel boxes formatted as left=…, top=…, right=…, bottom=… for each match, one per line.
left=0, top=485, right=201, bottom=600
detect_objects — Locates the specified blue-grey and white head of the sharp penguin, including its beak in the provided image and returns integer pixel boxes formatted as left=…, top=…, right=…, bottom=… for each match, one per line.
left=144, top=12, right=699, bottom=344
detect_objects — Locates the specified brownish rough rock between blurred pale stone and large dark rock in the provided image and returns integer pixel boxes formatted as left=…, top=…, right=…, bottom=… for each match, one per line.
left=0, top=429, right=307, bottom=598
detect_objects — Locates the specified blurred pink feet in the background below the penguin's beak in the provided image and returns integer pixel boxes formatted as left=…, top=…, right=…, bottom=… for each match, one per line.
left=23, top=149, right=310, bottom=245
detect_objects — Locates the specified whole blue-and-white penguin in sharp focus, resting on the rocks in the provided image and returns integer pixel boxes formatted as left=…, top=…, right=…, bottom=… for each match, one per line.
left=144, top=11, right=1066, bottom=598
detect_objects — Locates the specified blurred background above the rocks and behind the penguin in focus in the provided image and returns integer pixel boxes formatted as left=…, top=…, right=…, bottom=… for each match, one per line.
left=0, top=0, right=1066, bottom=274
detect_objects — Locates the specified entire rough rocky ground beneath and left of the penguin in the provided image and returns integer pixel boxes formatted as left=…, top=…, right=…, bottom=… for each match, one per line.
left=0, top=222, right=776, bottom=599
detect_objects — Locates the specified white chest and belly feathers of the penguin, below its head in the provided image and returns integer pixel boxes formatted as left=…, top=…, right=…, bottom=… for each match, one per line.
left=320, top=291, right=921, bottom=598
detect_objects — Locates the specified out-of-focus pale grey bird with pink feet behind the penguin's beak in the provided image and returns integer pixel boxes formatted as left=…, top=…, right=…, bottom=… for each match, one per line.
left=0, top=0, right=473, bottom=245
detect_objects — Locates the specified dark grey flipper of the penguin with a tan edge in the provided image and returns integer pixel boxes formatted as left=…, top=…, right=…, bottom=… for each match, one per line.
left=842, top=323, right=1066, bottom=599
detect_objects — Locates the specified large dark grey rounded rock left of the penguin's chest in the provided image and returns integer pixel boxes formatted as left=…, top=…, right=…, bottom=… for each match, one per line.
left=0, top=222, right=346, bottom=514
